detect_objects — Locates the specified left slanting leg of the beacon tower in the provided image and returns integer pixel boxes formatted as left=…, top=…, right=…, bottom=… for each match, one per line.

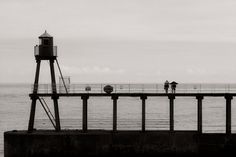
left=28, top=60, right=41, bottom=132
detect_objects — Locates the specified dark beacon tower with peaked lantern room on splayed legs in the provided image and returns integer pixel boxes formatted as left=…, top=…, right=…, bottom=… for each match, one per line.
left=28, top=31, right=61, bottom=132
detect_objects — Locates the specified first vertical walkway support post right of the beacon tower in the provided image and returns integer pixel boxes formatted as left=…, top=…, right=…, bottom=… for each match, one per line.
left=81, top=95, right=89, bottom=132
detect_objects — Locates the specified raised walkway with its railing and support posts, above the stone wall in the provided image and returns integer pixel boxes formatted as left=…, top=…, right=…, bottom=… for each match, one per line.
left=29, top=84, right=236, bottom=134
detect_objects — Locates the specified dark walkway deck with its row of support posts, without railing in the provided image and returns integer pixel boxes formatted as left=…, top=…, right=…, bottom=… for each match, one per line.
left=30, top=93, right=236, bottom=134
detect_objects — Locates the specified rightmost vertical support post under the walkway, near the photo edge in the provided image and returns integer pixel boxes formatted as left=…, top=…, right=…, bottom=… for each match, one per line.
left=225, top=95, right=233, bottom=134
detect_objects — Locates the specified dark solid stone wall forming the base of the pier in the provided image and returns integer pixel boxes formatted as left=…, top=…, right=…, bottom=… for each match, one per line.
left=4, top=130, right=236, bottom=157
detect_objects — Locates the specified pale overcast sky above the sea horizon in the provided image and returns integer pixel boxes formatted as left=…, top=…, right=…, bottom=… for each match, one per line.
left=0, top=0, right=236, bottom=83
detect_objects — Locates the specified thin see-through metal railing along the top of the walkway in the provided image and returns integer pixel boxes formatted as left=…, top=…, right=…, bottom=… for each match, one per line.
left=32, top=84, right=236, bottom=93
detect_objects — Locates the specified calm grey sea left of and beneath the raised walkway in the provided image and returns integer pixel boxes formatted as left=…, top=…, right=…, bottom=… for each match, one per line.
left=0, top=84, right=236, bottom=157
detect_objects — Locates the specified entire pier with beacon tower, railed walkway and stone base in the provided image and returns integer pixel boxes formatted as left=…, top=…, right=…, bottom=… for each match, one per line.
left=4, top=31, right=236, bottom=157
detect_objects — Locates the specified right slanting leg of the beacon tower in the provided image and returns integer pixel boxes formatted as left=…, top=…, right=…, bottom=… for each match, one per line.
left=50, top=59, right=61, bottom=131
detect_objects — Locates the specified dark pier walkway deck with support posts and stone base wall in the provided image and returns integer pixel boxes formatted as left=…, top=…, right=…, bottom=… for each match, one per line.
left=4, top=89, right=236, bottom=157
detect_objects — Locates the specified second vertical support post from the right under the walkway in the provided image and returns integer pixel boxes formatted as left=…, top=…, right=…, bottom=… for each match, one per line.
left=196, top=95, right=203, bottom=133
